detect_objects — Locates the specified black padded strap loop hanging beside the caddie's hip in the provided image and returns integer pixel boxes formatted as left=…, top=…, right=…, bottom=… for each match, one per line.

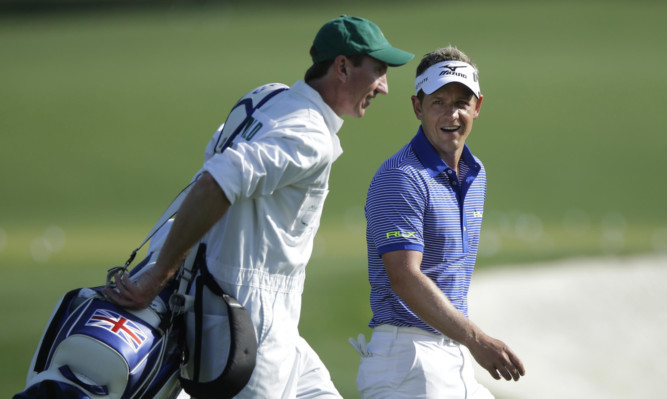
left=181, top=243, right=257, bottom=399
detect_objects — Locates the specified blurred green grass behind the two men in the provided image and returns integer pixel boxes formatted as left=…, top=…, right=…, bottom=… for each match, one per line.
left=0, top=1, right=667, bottom=398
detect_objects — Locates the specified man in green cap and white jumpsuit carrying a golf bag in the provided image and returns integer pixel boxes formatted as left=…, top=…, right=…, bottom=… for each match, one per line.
left=105, top=15, right=413, bottom=398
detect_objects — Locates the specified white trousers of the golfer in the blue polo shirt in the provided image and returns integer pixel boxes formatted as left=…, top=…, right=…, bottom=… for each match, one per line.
left=357, top=325, right=493, bottom=399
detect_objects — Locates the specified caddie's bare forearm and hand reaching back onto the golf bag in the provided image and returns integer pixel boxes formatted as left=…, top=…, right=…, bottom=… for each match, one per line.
left=104, top=172, right=231, bottom=309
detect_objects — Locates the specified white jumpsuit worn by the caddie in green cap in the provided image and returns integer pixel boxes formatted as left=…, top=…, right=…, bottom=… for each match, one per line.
left=180, top=81, right=343, bottom=399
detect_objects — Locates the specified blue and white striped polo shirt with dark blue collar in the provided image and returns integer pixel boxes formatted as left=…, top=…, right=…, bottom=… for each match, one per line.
left=366, top=127, right=486, bottom=333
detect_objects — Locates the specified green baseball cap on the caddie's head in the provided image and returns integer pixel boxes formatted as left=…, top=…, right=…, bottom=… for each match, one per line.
left=311, top=15, right=414, bottom=66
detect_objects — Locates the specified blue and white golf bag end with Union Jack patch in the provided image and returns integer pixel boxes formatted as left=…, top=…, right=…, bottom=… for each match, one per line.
left=14, top=254, right=183, bottom=399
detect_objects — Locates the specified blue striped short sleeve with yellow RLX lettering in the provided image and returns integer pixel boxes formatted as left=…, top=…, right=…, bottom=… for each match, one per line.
left=365, top=169, right=426, bottom=256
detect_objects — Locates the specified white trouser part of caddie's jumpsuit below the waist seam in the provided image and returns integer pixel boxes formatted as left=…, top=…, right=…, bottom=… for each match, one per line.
left=178, top=272, right=341, bottom=399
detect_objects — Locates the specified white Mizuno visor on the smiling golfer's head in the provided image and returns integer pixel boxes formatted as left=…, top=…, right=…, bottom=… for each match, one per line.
left=415, top=61, right=482, bottom=98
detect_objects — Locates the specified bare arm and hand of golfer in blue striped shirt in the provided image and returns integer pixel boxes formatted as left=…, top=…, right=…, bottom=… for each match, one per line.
left=382, top=250, right=525, bottom=381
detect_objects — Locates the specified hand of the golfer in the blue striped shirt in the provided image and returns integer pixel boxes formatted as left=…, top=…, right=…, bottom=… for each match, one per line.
left=466, top=333, right=526, bottom=381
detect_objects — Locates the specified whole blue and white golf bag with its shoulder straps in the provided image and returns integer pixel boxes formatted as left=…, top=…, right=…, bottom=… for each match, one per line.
left=14, top=84, right=287, bottom=399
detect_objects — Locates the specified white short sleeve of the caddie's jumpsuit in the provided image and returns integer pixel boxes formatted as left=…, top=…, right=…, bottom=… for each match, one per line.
left=203, top=112, right=332, bottom=203
